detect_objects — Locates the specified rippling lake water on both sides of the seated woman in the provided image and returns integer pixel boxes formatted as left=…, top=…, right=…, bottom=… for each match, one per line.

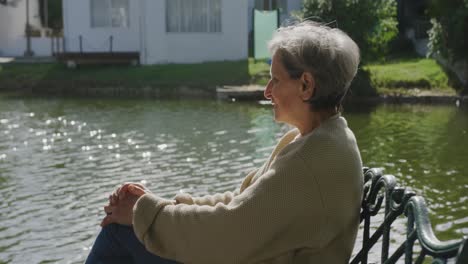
left=0, top=97, right=468, bottom=263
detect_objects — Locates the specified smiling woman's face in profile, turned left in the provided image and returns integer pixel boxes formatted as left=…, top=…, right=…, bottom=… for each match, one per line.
left=264, top=53, right=304, bottom=126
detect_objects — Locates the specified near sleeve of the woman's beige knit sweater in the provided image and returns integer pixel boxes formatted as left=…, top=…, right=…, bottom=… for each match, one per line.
left=133, top=156, right=323, bottom=263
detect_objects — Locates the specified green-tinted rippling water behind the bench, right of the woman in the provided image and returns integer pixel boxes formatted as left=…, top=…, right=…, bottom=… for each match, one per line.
left=348, top=105, right=468, bottom=239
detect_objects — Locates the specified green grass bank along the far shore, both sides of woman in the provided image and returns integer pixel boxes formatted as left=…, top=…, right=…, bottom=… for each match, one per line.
left=0, top=57, right=455, bottom=96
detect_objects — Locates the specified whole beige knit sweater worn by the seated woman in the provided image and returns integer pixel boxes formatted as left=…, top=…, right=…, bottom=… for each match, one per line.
left=133, top=115, right=363, bottom=264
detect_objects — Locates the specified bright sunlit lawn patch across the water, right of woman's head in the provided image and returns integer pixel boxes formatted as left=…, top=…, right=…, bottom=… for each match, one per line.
left=364, top=58, right=455, bottom=95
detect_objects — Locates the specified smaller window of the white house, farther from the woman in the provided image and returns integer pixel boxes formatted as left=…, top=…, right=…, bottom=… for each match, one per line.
left=91, top=0, right=130, bottom=28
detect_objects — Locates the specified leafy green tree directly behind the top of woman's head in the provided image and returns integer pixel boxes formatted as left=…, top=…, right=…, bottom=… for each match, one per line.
left=300, top=0, right=398, bottom=60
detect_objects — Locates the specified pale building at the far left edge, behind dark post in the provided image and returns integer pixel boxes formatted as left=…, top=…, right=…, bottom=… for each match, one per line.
left=0, top=0, right=51, bottom=56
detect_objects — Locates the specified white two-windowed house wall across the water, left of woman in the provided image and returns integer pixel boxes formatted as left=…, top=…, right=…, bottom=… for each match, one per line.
left=63, top=0, right=248, bottom=64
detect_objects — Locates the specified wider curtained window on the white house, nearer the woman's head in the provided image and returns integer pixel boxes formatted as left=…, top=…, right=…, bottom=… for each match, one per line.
left=166, top=0, right=221, bottom=32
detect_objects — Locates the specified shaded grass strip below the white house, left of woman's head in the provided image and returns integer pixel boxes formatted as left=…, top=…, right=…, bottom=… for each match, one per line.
left=0, top=59, right=269, bottom=87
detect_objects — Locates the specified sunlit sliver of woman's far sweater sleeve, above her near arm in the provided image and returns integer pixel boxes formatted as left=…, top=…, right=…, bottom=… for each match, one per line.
left=174, top=170, right=257, bottom=206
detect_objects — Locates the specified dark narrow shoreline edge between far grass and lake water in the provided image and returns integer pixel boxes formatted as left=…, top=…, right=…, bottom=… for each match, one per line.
left=0, top=81, right=468, bottom=105
